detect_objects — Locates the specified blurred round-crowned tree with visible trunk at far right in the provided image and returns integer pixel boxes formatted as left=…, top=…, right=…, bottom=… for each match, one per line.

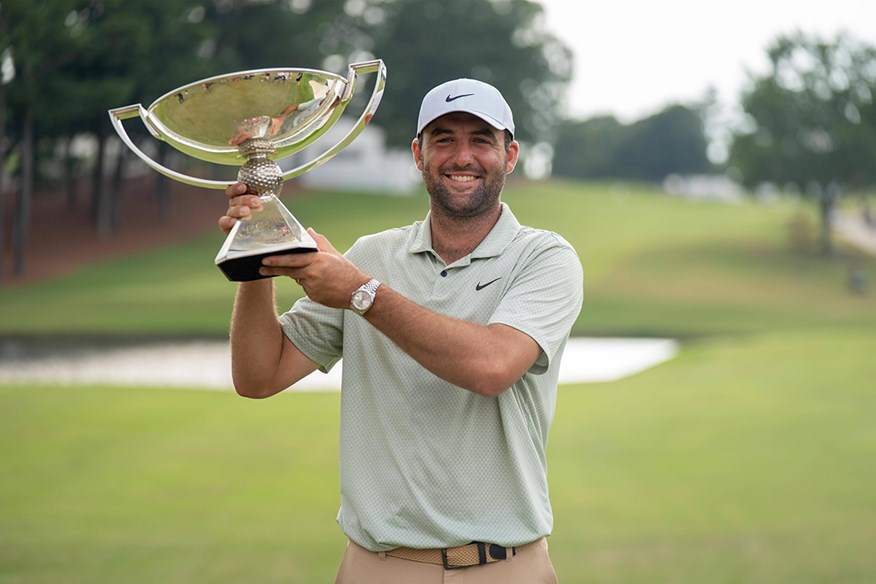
left=729, top=33, right=876, bottom=253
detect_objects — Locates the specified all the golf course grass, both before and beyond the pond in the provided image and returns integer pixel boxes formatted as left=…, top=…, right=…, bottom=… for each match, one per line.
left=0, top=183, right=876, bottom=584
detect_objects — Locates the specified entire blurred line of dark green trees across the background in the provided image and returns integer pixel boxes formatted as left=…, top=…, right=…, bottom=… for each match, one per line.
left=0, top=0, right=876, bottom=275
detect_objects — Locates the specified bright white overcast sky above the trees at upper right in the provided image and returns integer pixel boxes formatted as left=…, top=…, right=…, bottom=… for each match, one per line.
left=538, top=0, right=876, bottom=123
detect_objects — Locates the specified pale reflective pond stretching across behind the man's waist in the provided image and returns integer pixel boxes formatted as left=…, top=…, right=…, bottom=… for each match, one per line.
left=0, top=337, right=678, bottom=391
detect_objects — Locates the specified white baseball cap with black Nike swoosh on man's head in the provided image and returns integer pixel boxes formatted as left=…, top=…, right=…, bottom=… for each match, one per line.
left=417, top=79, right=514, bottom=136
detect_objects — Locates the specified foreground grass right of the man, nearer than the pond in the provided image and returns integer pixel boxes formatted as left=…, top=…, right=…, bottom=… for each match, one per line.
left=549, top=330, right=876, bottom=584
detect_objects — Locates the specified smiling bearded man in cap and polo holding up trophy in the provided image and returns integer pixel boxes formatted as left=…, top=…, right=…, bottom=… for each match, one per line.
left=219, top=79, right=582, bottom=584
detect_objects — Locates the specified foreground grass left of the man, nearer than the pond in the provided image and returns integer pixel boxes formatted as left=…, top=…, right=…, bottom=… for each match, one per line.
left=0, top=386, right=345, bottom=584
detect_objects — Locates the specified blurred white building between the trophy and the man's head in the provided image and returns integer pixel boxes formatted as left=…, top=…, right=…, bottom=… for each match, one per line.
left=279, top=118, right=422, bottom=196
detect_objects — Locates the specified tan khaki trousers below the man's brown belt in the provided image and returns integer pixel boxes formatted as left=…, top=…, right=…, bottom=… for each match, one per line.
left=335, top=539, right=557, bottom=584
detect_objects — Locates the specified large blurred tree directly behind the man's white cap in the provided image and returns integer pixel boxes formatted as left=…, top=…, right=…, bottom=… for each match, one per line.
left=364, top=0, right=572, bottom=147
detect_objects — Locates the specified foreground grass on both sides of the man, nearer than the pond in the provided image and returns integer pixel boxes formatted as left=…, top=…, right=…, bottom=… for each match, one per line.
left=0, top=330, right=876, bottom=584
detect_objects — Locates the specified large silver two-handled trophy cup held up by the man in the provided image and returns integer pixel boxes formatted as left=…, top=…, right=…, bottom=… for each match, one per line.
left=109, top=60, right=386, bottom=282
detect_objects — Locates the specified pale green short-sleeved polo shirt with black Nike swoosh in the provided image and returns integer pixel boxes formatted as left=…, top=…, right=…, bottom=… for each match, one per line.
left=281, top=204, right=583, bottom=551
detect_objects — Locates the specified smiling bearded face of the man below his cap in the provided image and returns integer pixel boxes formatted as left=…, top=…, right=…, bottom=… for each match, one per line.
left=412, top=112, right=519, bottom=218
